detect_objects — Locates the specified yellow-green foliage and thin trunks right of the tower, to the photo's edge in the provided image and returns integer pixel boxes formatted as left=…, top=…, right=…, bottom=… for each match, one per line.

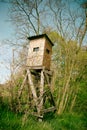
left=49, top=31, right=87, bottom=114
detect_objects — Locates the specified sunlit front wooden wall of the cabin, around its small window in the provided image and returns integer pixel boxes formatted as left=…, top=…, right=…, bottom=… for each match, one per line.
left=27, top=38, right=45, bottom=66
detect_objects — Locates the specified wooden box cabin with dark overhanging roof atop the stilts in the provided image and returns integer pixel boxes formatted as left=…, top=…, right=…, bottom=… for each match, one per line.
left=27, top=34, right=53, bottom=70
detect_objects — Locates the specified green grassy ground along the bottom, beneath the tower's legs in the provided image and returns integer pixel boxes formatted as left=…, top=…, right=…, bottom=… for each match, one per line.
left=0, top=102, right=87, bottom=130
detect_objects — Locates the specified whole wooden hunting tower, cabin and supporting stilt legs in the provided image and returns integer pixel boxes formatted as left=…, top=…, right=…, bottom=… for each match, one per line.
left=18, top=34, right=56, bottom=120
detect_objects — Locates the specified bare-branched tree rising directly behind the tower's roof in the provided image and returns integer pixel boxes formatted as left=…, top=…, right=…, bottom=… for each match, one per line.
left=10, top=0, right=48, bottom=36
